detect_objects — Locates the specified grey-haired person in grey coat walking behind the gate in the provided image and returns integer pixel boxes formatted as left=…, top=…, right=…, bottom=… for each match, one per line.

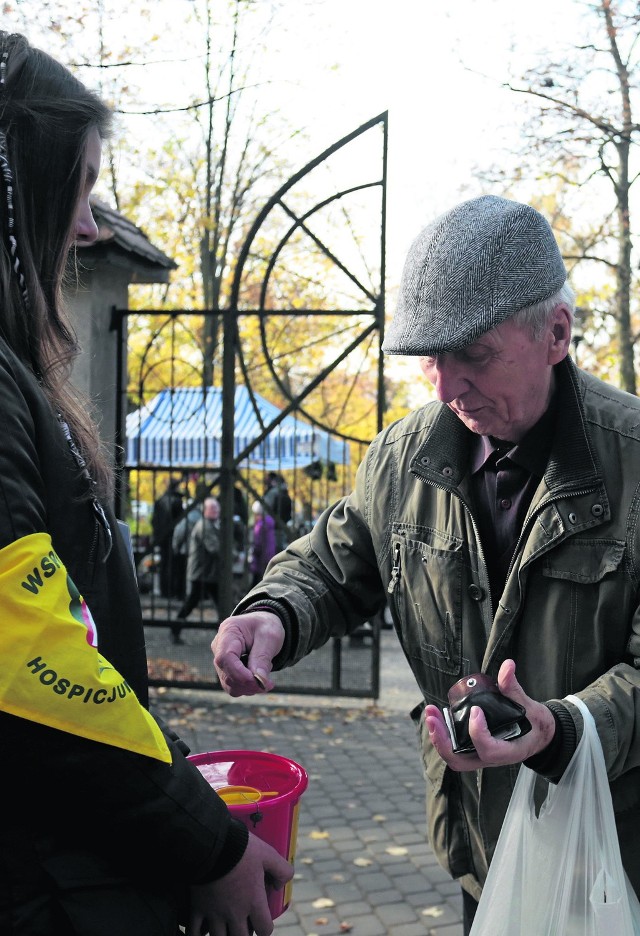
left=171, top=497, right=220, bottom=644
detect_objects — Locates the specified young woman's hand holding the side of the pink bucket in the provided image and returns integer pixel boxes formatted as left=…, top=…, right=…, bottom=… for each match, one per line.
left=187, top=833, right=293, bottom=936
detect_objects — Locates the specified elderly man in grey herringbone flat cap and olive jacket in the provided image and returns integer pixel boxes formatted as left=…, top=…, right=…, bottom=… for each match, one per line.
left=214, top=196, right=640, bottom=932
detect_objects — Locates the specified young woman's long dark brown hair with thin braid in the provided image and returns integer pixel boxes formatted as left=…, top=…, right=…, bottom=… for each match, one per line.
left=0, top=31, right=111, bottom=494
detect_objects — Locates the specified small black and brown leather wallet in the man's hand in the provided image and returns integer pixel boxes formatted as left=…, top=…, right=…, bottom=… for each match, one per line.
left=443, top=673, right=531, bottom=754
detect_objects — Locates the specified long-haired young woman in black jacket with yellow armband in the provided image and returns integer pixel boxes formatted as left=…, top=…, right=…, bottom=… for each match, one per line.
left=0, top=32, right=292, bottom=936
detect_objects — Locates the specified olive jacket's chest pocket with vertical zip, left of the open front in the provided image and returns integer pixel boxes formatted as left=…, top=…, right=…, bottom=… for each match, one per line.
left=388, top=530, right=464, bottom=684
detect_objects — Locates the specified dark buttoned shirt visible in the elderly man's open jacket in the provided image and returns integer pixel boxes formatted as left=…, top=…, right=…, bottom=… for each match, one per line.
left=471, top=403, right=556, bottom=609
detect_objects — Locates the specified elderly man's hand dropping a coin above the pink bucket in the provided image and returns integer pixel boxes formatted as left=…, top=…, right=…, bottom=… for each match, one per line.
left=211, top=611, right=285, bottom=696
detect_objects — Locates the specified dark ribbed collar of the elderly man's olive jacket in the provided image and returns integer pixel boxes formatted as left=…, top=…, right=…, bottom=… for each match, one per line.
left=410, top=357, right=602, bottom=492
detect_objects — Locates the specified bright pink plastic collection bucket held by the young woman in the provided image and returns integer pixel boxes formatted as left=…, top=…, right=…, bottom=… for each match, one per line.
left=189, top=751, right=309, bottom=920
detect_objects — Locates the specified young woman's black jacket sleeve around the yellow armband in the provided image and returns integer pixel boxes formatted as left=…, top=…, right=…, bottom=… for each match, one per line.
left=0, top=339, right=248, bottom=883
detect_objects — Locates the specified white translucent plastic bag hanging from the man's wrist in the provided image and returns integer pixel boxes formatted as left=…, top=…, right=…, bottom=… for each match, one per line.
left=471, top=696, right=640, bottom=936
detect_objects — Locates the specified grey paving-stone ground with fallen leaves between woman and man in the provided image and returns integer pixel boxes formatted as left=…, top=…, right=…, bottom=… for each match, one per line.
left=152, top=631, right=462, bottom=936
